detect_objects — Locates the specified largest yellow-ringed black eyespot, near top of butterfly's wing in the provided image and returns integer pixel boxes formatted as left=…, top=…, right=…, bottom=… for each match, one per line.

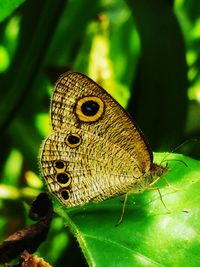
left=75, top=96, right=104, bottom=122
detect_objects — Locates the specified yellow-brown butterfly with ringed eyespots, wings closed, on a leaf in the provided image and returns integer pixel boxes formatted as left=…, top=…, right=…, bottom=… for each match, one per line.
left=40, top=72, right=166, bottom=207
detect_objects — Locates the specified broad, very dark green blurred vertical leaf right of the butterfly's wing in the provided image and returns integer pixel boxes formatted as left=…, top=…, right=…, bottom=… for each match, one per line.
left=126, top=0, right=188, bottom=151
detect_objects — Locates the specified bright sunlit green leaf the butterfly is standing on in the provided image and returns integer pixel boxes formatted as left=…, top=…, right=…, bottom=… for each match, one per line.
left=57, top=153, right=200, bottom=267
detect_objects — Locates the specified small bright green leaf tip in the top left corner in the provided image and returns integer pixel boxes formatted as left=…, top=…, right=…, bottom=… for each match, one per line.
left=0, top=0, right=25, bottom=22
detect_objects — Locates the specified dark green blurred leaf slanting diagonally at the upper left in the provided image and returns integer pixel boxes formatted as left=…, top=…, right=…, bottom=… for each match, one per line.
left=0, top=0, right=65, bottom=136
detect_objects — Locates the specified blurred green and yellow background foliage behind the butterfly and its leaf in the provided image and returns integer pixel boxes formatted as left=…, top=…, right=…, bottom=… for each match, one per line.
left=0, top=0, right=200, bottom=266
